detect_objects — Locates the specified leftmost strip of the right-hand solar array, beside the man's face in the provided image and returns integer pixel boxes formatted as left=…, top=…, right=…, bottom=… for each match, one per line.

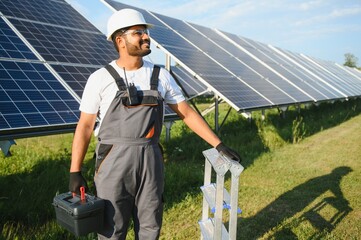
left=102, top=1, right=272, bottom=110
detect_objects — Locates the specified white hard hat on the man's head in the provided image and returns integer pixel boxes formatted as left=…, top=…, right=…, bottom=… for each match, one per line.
left=107, top=8, right=153, bottom=41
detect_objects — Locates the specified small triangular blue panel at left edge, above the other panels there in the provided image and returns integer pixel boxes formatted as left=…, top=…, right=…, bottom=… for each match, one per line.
left=0, top=18, right=37, bottom=60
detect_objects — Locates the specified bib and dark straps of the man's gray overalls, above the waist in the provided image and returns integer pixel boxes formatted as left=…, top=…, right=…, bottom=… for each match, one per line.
left=99, top=65, right=163, bottom=139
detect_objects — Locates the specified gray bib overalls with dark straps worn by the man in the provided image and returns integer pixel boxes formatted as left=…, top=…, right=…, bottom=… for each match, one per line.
left=94, top=65, right=164, bottom=240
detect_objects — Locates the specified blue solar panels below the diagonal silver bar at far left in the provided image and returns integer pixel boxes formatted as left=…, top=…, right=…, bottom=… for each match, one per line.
left=0, top=15, right=79, bottom=139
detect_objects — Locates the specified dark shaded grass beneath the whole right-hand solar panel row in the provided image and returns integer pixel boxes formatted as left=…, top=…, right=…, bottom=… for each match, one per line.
left=163, top=99, right=361, bottom=212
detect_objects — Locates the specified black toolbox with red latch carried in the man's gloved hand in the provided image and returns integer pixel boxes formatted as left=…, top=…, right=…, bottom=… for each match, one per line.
left=53, top=192, right=104, bottom=236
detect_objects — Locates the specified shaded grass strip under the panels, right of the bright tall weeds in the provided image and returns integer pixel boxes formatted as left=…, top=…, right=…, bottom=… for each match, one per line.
left=266, top=99, right=361, bottom=143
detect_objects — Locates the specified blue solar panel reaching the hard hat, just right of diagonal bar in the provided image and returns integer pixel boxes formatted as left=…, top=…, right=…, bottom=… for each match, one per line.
left=10, top=19, right=117, bottom=66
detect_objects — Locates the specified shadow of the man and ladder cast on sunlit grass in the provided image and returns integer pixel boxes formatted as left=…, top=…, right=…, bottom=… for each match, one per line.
left=237, top=166, right=352, bottom=239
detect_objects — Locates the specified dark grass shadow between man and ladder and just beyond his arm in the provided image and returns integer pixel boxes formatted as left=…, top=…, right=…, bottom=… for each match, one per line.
left=162, top=111, right=268, bottom=209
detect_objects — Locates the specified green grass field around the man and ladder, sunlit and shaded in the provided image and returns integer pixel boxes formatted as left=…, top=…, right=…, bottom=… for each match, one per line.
left=0, top=99, right=361, bottom=239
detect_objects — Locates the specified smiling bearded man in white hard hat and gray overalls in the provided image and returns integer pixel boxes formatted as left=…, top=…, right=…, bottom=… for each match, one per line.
left=69, top=9, right=240, bottom=240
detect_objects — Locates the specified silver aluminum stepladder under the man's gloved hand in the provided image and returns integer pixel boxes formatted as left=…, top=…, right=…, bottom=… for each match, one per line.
left=198, top=148, right=244, bottom=240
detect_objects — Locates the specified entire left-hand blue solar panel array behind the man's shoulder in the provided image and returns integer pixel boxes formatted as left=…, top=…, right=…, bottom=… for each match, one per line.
left=0, top=0, right=204, bottom=140
